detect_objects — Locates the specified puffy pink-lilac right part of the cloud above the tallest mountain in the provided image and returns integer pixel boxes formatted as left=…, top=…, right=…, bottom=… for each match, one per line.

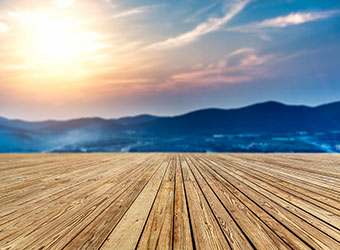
left=163, top=48, right=308, bottom=92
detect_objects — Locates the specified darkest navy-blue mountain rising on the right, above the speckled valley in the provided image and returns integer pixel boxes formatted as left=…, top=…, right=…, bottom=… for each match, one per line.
left=131, top=101, right=340, bottom=134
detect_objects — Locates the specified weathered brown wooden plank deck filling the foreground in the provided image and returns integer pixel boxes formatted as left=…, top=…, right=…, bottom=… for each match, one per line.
left=0, top=153, right=340, bottom=250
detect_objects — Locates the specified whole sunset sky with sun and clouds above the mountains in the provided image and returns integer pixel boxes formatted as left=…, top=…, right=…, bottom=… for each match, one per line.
left=0, top=0, right=340, bottom=120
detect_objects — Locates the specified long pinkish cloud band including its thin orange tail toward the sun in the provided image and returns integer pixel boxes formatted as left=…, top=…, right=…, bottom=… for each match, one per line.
left=90, top=48, right=276, bottom=94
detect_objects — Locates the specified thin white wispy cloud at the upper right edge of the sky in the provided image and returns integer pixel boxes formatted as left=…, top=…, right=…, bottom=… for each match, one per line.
left=227, top=10, right=340, bottom=32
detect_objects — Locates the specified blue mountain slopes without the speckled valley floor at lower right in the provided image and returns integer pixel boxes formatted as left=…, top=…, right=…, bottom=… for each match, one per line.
left=0, top=101, right=340, bottom=152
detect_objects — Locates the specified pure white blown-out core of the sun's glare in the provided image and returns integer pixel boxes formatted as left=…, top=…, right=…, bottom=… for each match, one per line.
left=15, top=11, right=108, bottom=76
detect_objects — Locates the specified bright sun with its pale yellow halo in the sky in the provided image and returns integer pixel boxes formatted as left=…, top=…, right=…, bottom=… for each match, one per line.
left=8, top=7, right=113, bottom=89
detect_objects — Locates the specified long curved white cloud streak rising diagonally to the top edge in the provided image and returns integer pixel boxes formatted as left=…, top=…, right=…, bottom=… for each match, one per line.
left=147, top=0, right=249, bottom=49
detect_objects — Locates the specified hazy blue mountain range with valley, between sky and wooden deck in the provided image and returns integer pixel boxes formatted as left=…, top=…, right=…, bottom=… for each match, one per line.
left=0, top=101, right=340, bottom=152
